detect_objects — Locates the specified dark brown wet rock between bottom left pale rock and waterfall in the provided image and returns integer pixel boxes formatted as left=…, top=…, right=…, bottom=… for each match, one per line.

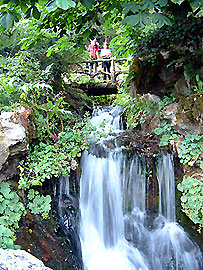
left=15, top=213, right=80, bottom=270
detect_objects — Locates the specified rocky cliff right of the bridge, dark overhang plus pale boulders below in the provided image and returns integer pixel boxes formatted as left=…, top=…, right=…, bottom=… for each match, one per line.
left=129, top=16, right=203, bottom=181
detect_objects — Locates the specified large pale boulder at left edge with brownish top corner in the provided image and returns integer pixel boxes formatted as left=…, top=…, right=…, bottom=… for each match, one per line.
left=0, top=107, right=34, bottom=181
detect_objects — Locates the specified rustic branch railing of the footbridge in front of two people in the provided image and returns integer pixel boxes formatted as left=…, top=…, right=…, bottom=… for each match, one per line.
left=68, top=58, right=128, bottom=83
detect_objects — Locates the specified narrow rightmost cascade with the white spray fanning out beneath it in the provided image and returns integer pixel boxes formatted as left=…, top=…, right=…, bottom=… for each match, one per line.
left=149, top=154, right=202, bottom=270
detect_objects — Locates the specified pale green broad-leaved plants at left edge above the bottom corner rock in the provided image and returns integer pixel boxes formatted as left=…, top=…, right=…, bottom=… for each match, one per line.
left=0, top=182, right=51, bottom=249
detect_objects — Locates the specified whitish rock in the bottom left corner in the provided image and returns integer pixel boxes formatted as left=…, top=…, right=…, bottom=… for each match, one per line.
left=0, top=249, right=51, bottom=270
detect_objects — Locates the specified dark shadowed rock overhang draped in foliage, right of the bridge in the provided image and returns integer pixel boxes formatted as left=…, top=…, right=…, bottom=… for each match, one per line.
left=130, top=18, right=203, bottom=97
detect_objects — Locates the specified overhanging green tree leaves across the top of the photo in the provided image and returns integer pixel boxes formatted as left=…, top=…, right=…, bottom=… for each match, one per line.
left=0, top=0, right=203, bottom=51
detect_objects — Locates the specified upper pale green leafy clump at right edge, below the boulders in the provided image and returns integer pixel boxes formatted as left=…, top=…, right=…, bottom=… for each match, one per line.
left=178, top=134, right=203, bottom=166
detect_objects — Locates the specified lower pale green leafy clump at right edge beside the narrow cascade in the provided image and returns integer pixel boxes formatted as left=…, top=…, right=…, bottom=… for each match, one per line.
left=177, top=177, right=203, bottom=229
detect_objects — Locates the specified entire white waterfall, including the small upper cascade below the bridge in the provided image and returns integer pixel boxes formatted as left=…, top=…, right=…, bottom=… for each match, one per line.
left=80, top=106, right=201, bottom=270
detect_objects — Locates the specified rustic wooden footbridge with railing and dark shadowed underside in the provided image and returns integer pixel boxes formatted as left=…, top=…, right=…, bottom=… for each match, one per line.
left=66, top=58, right=128, bottom=96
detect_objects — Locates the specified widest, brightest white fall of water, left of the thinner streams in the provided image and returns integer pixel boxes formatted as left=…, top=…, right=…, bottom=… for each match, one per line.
left=80, top=152, right=148, bottom=270
